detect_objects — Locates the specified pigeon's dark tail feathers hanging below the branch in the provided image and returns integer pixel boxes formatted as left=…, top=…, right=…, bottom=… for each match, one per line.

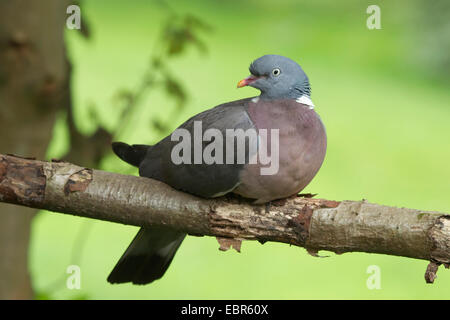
left=108, top=227, right=186, bottom=284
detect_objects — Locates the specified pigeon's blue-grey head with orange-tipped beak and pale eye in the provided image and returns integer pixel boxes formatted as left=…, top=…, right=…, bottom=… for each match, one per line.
left=238, top=54, right=311, bottom=99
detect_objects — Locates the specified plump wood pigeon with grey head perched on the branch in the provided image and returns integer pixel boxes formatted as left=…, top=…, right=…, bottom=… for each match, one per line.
left=108, top=55, right=327, bottom=284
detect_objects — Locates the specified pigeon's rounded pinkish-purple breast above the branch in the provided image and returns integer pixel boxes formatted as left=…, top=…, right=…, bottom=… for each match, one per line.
left=233, top=99, right=327, bottom=203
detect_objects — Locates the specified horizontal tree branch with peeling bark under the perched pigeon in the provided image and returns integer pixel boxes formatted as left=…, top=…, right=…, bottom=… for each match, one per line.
left=0, top=154, right=450, bottom=283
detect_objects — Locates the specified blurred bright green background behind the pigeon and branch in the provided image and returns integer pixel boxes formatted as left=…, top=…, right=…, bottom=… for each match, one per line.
left=30, top=0, right=450, bottom=299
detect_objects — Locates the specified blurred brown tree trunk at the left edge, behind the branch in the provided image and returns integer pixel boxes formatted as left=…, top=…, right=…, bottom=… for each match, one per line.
left=0, top=0, right=69, bottom=299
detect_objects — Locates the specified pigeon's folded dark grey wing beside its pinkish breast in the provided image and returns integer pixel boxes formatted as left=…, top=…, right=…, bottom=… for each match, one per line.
left=139, top=99, right=257, bottom=198
